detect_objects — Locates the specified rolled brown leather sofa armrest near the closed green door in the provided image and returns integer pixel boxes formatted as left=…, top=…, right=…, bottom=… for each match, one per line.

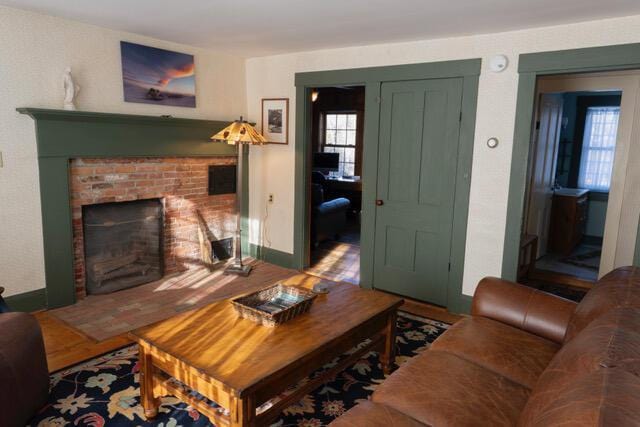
left=471, top=277, right=577, bottom=343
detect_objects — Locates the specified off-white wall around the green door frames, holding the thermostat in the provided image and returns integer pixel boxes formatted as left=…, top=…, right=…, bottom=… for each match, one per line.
left=246, top=12, right=640, bottom=295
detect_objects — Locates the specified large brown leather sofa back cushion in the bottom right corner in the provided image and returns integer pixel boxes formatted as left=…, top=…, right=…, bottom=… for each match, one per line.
left=522, top=308, right=640, bottom=425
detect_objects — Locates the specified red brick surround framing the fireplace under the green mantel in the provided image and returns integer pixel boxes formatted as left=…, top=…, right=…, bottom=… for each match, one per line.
left=70, top=157, right=236, bottom=299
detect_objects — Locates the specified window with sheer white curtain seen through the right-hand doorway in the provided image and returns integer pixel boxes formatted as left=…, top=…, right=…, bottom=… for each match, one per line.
left=578, top=107, right=620, bottom=191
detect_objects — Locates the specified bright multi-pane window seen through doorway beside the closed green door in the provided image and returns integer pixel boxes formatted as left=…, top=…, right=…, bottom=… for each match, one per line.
left=322, top=113, right=357, bottom=176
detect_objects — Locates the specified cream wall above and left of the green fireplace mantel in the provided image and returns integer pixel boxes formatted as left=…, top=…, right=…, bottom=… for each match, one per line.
left=0, top=7, right=246, bottom=296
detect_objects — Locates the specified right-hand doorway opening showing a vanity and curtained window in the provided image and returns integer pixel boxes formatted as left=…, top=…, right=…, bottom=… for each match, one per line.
left=518, top=72, right=640, bottom=300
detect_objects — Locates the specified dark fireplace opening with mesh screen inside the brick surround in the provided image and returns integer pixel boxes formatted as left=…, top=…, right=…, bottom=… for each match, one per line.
left=82, top=199, right=164, bottom=295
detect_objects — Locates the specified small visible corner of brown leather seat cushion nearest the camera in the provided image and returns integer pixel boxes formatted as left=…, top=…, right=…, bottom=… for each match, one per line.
left=329, top=400, right=424, bottom=427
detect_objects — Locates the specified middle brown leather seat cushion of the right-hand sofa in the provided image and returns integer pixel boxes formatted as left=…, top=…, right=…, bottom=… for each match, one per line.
left=372, top=352, right=530, bottom=426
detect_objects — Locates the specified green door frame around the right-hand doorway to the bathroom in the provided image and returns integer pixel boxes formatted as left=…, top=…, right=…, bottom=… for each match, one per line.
left=502, top=43, right=640, bottom=280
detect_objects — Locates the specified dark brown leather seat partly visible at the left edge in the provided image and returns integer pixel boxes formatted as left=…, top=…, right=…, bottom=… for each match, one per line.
left=0, top=313, right=49, bottom=427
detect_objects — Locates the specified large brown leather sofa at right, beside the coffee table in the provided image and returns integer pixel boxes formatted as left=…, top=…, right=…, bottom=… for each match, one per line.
left=331, top=267, right=640, bottom=427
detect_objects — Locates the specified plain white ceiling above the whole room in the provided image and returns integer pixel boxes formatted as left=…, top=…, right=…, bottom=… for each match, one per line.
left=0, top=0, right=640, bottom=57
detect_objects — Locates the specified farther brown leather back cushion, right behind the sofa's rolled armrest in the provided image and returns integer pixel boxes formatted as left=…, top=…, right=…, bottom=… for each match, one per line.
left=564, top=267, right=640, bottom=342
